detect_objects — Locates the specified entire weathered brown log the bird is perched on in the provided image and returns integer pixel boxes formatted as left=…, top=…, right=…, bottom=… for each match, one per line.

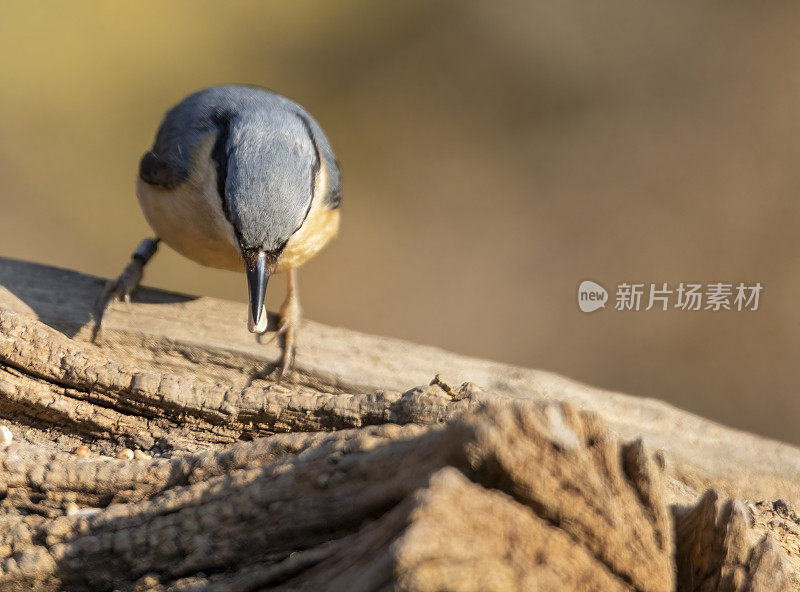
left=0, top=260, right=800, bottom=592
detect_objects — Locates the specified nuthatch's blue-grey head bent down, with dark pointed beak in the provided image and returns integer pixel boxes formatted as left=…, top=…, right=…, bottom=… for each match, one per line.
left=219, top=110, right=320, bottom=333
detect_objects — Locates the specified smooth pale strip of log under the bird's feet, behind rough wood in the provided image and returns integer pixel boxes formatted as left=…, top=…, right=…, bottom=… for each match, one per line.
left=0, top=258, right=800, bottom=503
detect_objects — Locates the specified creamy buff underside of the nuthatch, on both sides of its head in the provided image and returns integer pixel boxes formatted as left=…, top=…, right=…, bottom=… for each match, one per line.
left=136, top=136, right=339, bottom=272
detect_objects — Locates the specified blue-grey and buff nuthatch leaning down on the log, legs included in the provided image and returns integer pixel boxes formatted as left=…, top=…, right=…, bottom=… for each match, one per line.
left=92, top=85, right=342, bottom=380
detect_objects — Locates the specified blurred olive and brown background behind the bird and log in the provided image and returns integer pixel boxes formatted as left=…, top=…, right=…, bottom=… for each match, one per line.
left=0, top=0, right=800, bottom=443
